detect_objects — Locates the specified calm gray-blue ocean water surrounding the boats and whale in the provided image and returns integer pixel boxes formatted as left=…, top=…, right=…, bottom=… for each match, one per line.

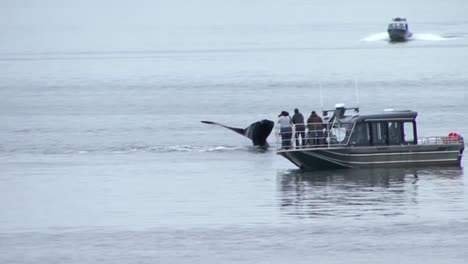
left=0, top=0, right=468, bottom=264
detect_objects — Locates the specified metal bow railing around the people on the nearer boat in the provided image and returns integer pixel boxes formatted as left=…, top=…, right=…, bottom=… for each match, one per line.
left=275, top=123, right=354, bottom=150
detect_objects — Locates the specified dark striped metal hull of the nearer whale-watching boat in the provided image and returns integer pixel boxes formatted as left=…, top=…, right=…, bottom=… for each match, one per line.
left=278, top=144, right=461, bottom=170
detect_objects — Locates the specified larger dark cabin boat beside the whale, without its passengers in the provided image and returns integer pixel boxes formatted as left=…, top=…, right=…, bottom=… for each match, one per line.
left=277, top=104, right=464, bottom=170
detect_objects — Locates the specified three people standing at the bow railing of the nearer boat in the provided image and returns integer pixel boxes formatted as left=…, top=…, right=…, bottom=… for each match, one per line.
left=277, top=108, right=328, bottom=149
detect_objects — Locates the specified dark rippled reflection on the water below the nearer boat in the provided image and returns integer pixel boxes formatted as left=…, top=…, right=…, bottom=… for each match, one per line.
left=277, top=167, right=463, bottom=220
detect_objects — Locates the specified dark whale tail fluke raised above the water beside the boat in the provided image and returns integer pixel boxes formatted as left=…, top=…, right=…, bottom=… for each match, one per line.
left=201, top=119, right=275, bottom=147
